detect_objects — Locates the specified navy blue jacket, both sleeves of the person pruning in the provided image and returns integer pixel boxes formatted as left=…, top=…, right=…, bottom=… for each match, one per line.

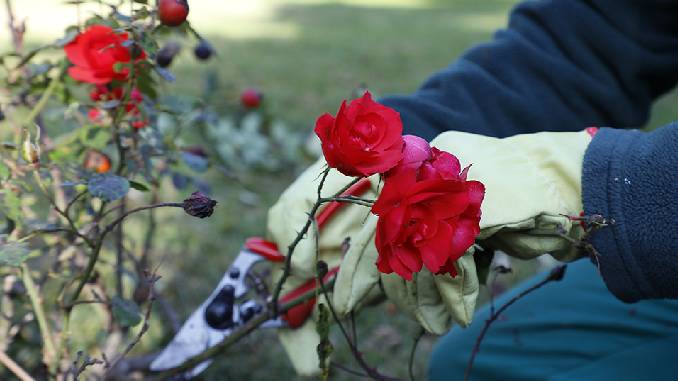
left=381, top=0, right=678, bottom=301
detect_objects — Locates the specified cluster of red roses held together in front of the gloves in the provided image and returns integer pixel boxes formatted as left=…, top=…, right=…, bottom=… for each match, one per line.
left=315, top=93, right=485, bottom=280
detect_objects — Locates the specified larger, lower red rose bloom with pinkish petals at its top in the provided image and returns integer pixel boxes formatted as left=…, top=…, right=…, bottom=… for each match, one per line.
left=372, top=136, right=485, bottom=280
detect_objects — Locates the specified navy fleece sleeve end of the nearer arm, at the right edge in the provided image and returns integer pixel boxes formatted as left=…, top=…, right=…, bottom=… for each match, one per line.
left=582, top=123, right=678, bottom=302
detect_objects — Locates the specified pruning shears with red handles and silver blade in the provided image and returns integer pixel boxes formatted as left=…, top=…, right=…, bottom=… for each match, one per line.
left=150, top=179, right=370, bottom=379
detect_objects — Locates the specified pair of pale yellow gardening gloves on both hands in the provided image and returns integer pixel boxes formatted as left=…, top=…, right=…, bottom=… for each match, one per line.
left=269, top=127, right=591, bottom=374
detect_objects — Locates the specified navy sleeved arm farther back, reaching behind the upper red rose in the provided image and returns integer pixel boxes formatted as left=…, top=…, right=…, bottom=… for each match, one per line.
left=380, top=0, right=678, bottom=140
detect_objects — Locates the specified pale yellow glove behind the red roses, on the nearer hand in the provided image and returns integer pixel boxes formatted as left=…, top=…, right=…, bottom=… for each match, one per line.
left=334, top=131, right=591, bottom=324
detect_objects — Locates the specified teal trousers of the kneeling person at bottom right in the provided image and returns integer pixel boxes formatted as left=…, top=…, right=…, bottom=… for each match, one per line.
left=428, top=260, right=678, bottom=381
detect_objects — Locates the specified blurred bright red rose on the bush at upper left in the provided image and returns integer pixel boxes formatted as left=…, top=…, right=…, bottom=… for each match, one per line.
left=64, top=25, right=146, bottom=85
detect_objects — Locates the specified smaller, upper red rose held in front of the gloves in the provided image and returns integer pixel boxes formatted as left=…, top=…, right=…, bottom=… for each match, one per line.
left=315, top=92, right=403, bottom=176
